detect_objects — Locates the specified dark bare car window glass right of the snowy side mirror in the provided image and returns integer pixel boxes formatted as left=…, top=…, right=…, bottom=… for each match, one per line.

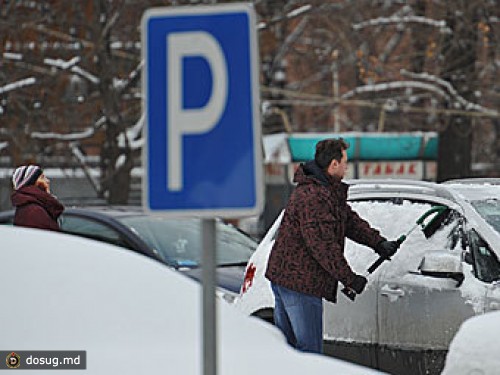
left=469, top=230, right=500, bottom=283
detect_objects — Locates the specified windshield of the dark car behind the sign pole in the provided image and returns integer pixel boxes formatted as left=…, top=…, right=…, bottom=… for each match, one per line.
left=119, top=216, right=257, bottom=267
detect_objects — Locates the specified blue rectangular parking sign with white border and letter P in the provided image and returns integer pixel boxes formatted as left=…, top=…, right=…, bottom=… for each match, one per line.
left=142, top=4, right=263, bottom=217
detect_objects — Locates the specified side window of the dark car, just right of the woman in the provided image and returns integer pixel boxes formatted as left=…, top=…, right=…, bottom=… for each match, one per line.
left=60, top=215, right=130, bottom=248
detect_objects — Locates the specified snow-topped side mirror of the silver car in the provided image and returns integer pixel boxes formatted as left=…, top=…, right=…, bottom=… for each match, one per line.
left=418, top=250, right=465, bottom=288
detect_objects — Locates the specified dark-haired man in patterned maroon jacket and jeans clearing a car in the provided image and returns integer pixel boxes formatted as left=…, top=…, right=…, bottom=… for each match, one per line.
left=266, top=138, right=398, bottom=353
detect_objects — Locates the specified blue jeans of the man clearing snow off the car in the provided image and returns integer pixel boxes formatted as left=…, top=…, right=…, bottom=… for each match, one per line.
left=271, top=283, right=323, bottom=353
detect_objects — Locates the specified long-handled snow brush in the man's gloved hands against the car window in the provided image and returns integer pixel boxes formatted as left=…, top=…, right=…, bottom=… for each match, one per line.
left=342, top=206, right=451, bottom=301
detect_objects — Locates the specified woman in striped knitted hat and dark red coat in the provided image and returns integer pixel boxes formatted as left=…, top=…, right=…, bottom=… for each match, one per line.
left=11, top=165, right=64, bottom=231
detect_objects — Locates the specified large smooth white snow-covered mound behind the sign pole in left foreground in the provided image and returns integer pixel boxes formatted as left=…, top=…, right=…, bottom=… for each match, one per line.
left=0, top=227, right=377, bottom=375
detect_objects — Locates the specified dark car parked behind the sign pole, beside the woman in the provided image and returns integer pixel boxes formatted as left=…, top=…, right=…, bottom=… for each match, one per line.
left=0, top=207, right=257, bottom=302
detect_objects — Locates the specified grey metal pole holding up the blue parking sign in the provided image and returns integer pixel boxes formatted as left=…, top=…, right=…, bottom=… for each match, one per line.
left=202, top=219, right=217, bottom=375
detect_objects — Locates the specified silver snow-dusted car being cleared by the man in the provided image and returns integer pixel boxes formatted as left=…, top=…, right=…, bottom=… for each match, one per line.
left=235, top=179, right=500, bottom=375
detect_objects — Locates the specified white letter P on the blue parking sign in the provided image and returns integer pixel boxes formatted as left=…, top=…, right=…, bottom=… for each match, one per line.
left=166, top=32, right=228, bottom=191
